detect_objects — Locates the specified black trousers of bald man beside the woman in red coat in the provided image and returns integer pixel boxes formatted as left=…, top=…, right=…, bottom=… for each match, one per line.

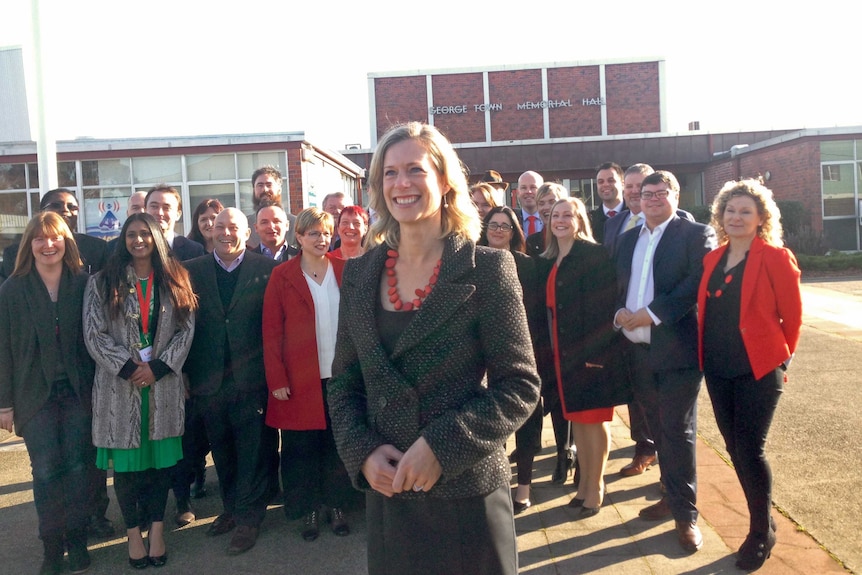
left=195, top=381, right=278, bottom=527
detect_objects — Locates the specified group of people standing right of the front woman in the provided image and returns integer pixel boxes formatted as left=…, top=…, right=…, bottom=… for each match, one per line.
left=482, top=162, right=802, bottom=570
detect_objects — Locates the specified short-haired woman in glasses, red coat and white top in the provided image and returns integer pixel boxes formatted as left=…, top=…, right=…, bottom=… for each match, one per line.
left=263, top=208, right=350, bottom=541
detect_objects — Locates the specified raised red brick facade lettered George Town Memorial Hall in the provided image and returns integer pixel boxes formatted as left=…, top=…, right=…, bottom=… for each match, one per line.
left=373, top=62, right=662, bottom=144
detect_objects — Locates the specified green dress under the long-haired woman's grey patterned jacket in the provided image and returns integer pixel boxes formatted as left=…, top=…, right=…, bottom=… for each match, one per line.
left=96, top=280, right=183, bottom=472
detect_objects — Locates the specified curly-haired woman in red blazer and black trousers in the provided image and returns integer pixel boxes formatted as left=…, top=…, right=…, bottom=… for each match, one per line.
left=698, top=180, right=802, bottom=570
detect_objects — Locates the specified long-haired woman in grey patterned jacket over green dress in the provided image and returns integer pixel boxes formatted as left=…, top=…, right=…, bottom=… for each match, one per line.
left=84, top=214, right=197, bottom=569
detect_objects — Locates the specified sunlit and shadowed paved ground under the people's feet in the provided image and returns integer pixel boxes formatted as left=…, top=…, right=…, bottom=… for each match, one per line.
left=0, top=281, right=862, bottom=575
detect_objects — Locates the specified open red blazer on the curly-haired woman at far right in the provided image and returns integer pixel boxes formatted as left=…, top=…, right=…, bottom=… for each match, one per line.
left=697, top=238, right=802, bottom=379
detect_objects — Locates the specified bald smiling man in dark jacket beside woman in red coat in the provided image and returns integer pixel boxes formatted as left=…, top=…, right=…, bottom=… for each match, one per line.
left=183, top=208, right=278, bottom=555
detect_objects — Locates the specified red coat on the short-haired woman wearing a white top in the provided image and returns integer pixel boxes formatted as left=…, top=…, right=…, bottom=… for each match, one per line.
left=263, top=254, right=344, bottom=431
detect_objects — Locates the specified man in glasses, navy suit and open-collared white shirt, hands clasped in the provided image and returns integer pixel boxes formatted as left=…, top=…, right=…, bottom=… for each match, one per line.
left=614, top=171, right=715, bottom=552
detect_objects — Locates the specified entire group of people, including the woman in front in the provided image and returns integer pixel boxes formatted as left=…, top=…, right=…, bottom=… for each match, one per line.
left=0, top=122, right=801, bottom=575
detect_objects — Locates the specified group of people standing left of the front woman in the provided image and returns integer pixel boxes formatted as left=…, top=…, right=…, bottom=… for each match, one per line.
left=0, top=167, right=368, bottom=573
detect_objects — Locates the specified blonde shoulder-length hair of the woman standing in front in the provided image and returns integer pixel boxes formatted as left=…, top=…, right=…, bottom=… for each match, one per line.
left=368, top=122, right=482, bottom=249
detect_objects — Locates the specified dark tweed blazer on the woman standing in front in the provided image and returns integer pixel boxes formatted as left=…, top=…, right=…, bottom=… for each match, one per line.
left=327, top=236, right=539, bottom=498
